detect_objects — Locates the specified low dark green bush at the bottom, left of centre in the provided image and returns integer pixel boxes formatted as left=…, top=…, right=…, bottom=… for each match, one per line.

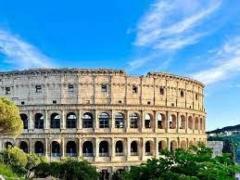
left=35, top=159, right=99, bottom=180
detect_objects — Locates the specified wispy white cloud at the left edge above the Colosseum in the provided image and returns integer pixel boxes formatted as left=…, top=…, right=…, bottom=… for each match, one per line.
left=0, top=29, right=53, bottom=69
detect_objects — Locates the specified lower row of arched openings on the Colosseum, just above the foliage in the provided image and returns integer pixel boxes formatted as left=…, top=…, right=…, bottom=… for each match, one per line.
left=5, top=140, right=194, bottom=157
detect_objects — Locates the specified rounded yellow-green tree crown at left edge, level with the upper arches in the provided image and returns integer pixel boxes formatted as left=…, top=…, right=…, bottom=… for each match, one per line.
left=0, top=97, right=23, bottom=136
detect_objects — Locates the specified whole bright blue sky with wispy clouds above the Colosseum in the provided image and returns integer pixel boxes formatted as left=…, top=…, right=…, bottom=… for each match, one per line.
left=0, top=0, right=240, bottom=130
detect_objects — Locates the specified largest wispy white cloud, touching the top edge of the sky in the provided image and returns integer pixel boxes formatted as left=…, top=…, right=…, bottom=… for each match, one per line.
left=129, top=0, right=222, bottom=68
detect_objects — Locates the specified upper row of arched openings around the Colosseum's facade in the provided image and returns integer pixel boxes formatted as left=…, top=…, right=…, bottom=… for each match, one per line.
left=20, top=112, right=204, bottom=130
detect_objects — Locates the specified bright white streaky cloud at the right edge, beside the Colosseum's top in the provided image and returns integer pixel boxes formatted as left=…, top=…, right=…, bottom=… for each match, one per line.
left=192, top=36, right=240, bottom=85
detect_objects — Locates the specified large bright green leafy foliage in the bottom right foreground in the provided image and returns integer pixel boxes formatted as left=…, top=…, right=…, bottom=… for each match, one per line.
left=120, top=144, right=240, bottom=180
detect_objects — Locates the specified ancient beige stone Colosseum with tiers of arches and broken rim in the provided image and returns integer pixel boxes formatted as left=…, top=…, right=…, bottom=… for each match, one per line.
left=0, top=69, right=206, bottom=179
